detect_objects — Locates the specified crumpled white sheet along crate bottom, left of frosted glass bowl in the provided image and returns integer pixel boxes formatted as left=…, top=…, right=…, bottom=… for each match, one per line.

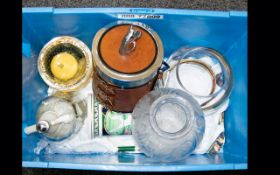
left=34, top=133, right=140, bottom=154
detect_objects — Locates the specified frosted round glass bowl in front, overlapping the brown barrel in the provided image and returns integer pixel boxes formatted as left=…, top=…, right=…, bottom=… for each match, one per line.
left=132, top=88, right=205, bottom=162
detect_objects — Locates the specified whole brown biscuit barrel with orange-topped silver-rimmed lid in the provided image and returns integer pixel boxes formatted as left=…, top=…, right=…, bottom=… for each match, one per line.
left=92, top=21, right=163, bottom=112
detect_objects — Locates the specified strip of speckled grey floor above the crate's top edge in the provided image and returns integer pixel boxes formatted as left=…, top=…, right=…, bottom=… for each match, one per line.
left=22, top=0, right=247, bottom=10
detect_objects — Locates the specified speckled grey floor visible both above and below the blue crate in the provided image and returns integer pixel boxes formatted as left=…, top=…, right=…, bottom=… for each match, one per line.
left=22, top=0, right=247, bottom=175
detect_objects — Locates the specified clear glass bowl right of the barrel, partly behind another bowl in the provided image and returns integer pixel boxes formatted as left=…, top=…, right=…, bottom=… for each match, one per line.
left=163, top=46, right=233, bottom=111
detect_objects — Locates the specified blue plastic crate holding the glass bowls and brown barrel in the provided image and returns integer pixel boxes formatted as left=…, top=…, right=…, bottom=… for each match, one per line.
left=22, top=8, right=248, bottom=171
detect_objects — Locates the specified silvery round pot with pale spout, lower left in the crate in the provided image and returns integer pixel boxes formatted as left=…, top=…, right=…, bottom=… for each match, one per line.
left=24, top=96, right=82, bottom=140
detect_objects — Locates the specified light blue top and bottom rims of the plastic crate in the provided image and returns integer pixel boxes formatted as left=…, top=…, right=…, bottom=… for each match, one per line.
left=22, top=7, right=248, bottom=172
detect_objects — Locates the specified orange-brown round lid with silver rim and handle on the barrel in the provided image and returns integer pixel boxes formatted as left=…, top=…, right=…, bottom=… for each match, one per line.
left=92, top=21, right=163, bottom=88
